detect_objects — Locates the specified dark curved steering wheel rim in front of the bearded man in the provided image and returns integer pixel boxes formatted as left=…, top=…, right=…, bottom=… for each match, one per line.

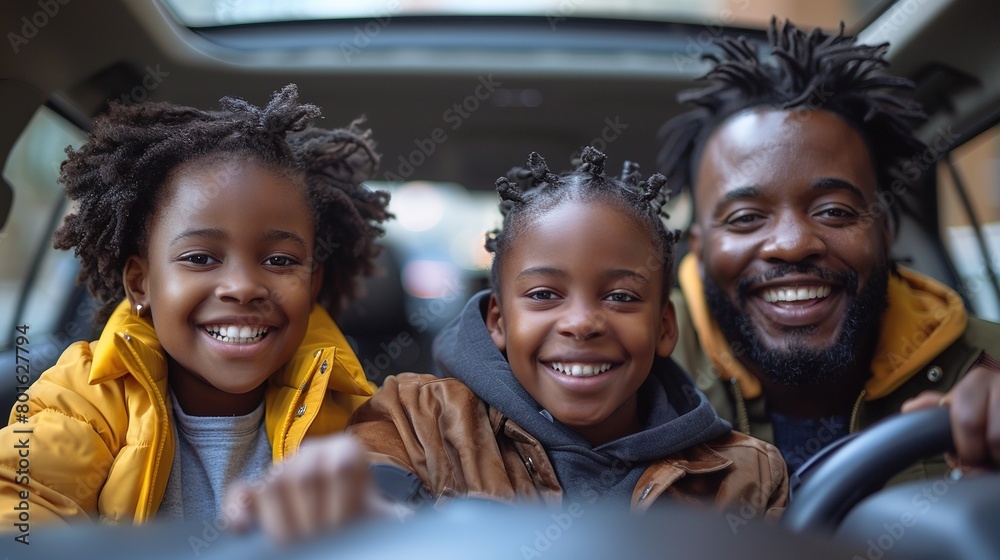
left=781, top=407, right=954, bottom=532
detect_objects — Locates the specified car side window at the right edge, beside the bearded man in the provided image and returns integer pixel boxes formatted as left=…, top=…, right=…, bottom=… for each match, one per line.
left=938, top=125, right=1000, bottom=321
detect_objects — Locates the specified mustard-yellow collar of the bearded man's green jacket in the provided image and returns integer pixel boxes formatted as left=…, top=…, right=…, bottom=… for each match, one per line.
left=677, top=253, right=968, bottom=400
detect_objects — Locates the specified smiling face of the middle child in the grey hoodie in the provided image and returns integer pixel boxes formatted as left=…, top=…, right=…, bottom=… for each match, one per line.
left=487, top=200, right=677, bottom=445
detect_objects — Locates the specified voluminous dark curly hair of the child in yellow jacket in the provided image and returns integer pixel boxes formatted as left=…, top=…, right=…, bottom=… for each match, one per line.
left=54, top=84, right=390, bottom=322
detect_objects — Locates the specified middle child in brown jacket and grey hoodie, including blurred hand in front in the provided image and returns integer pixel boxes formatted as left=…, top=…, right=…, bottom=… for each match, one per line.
left=229, top=148, right=787, bottom=538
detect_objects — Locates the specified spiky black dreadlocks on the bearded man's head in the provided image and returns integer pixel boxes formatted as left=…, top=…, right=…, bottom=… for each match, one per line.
left=659, top=18, right=926, bottom=225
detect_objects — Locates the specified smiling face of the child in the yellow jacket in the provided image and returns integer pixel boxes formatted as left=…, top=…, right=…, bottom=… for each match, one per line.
left=125, top=160, right=320, bottom=416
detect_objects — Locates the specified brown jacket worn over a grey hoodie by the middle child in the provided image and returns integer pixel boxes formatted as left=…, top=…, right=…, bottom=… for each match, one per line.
left=348, top=374, right=788, bottom=516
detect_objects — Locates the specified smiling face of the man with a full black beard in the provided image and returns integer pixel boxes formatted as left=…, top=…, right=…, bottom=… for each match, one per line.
left=691, top=109, right=890, bottom=385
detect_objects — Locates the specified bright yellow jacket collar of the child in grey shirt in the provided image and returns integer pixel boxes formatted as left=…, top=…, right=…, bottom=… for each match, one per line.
left=89, top=300, right=373, bottom=396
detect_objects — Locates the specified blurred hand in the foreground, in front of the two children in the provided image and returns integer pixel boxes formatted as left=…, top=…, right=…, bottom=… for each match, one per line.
left=223, top=434, right=393, bottom=543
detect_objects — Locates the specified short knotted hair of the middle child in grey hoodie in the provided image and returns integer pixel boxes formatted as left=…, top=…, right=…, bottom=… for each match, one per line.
left=486, top=146, right=679, bottom=302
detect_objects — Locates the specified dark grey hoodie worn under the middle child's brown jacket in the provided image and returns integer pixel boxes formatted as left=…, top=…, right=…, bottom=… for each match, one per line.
left=433, top=290, right=732, bottom=506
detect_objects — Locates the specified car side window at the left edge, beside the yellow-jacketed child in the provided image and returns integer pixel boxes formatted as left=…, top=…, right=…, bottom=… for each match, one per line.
left=0, top=107, right=84, bottom=349
